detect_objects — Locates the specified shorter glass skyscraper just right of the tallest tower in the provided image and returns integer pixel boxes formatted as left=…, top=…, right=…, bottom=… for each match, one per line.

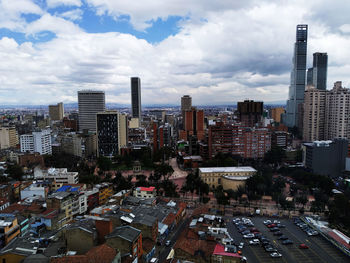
left=312, top=52, right=328, bottom=90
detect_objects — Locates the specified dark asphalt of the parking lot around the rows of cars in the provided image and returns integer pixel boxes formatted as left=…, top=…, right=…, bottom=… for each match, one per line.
left=227, top=217, right=350, bottom=263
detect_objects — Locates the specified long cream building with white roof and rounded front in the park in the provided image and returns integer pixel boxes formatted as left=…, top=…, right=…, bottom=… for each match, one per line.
left=199, top=166, right=256, bottom=190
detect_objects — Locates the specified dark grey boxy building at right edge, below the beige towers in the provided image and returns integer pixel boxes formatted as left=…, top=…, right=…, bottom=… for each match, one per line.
left=303, top=139, right=348, bottom=177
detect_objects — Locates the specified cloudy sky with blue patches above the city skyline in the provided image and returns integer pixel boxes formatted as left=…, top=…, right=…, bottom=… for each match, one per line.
left=0, top=0, right=350, bottom=105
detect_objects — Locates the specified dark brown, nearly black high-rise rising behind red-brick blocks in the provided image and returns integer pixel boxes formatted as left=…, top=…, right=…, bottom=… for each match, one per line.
left=237, top=100, right=264, bottom=127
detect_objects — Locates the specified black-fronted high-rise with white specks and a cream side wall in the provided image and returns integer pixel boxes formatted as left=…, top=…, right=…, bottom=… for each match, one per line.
left=96, top=111, right=128, bottom=157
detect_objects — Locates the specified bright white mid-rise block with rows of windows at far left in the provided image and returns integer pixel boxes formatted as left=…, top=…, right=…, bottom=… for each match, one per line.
left=20, top=129, right=52, bottom=154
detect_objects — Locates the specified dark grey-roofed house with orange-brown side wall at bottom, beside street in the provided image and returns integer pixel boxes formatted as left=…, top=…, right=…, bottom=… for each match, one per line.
left=105, top=226, right=143, bottom=259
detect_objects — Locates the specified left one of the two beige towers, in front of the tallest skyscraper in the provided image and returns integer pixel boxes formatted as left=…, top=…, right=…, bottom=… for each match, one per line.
left=303, top=86, right=327, bottom=142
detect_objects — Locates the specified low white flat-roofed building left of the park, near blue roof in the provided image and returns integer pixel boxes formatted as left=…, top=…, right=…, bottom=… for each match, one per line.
left=34, top=167, right=79, bottom=184
